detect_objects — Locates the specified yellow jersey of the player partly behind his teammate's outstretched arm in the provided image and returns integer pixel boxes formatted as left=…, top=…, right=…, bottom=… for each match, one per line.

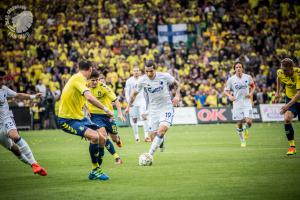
left=87, top=82, right=117, bottom=114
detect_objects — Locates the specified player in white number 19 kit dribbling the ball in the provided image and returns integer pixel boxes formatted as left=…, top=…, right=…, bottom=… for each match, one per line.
left=125, top=62, right=180, bottom=159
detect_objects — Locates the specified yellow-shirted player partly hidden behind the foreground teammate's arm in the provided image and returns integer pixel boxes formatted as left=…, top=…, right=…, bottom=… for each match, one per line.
left=87, top=70, right=125, bottom=164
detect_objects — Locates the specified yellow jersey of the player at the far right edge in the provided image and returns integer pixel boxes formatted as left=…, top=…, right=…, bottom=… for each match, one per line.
left=277, top=67, right=300, bottom=102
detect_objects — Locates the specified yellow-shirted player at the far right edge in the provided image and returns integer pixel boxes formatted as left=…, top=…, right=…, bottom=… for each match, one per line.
left=275, top=58, right=300, bottom=155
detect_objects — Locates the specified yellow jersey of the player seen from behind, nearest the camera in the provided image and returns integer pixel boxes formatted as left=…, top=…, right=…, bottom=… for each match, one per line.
left=58, top=73, right=89, bottom=120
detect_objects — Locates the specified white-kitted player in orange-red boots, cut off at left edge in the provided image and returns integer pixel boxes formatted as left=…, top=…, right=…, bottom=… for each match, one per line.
left=0, top=71, right=47, bottom=176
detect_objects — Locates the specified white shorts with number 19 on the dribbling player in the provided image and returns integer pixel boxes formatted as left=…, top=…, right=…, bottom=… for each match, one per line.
left=148, top=107, right=174, bottom=132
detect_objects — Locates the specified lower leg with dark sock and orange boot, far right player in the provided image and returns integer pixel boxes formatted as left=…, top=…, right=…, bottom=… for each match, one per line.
left=284, top=111, right=296, bottom=156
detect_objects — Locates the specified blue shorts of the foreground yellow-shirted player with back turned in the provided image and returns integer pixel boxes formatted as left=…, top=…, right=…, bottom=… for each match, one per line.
left=57, top=117, right=100, bottom=137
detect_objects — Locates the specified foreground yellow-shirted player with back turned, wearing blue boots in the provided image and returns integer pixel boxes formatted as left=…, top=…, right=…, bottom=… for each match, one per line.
left=58, top=60, right=113, bottom=180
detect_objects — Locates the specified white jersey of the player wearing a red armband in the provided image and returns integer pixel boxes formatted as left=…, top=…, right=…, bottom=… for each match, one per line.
left=225, top=73, right=253, bottom=109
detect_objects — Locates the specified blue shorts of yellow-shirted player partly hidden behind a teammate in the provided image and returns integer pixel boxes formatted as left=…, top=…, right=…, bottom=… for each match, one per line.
left=91, top=114, right=118, bottom=135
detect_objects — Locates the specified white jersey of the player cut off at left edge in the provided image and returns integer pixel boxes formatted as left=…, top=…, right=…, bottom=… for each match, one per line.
left=0, top=85, right=17, bottom=123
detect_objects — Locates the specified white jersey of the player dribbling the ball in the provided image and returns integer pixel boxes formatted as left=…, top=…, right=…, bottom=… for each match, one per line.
left=136, top=72, right=175, bottom=112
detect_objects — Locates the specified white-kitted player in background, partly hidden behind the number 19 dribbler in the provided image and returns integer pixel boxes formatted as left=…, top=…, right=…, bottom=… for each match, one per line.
left=125, top=66, right=151, bottom=142
